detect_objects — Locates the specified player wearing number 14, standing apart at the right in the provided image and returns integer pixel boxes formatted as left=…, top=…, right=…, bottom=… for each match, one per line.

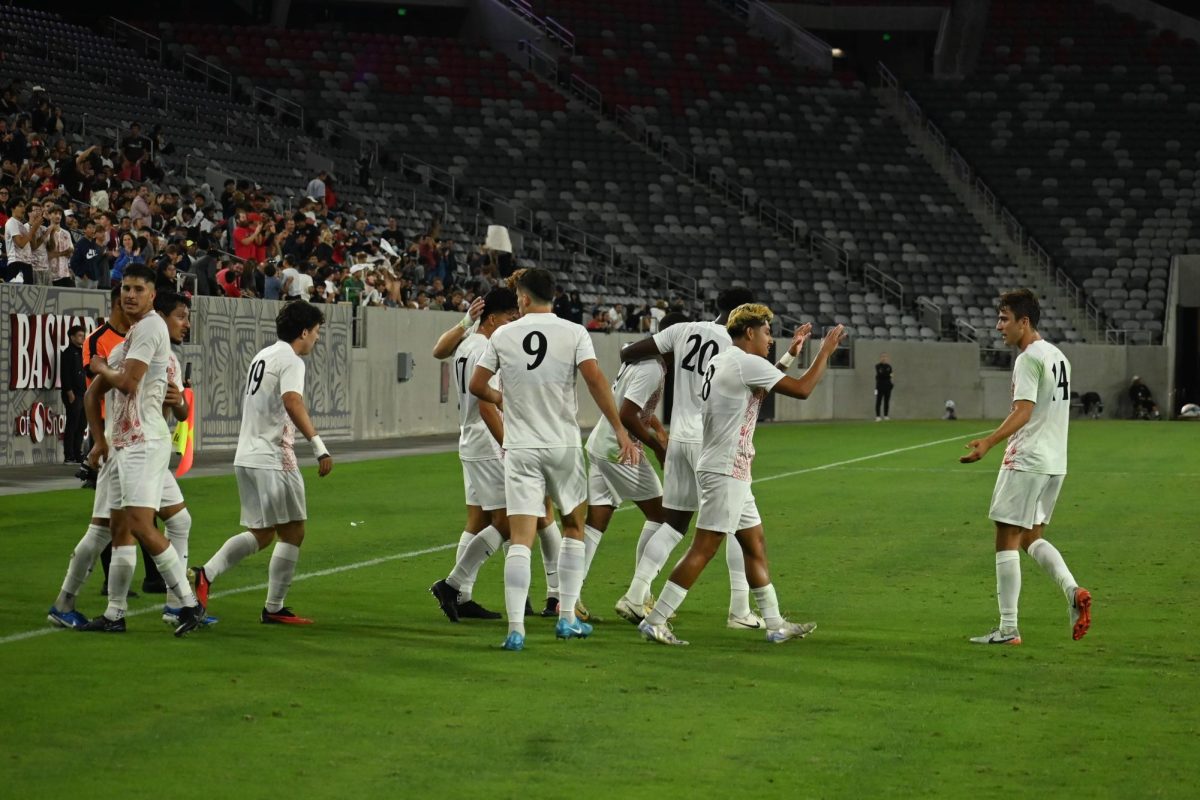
left=959, top=289, right=1092, bottom=645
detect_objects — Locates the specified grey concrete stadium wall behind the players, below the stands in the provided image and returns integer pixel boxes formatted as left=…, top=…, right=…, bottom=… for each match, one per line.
left=0, top=284, right=1168, bottom=465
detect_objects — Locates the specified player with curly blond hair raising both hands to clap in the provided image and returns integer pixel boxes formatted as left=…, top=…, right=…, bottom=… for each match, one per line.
left=637, top=303, right=845, bottom=644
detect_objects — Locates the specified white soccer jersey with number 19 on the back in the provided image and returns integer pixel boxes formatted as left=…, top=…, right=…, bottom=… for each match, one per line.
left=233, top=341, right=305, bottom=471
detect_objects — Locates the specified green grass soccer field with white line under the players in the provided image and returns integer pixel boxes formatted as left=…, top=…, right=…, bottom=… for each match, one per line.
left=0, top=421, right=1200, bottom=799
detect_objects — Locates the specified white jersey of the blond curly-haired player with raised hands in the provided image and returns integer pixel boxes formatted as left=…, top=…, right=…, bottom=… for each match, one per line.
left=700, top=345, right=784, bottom=481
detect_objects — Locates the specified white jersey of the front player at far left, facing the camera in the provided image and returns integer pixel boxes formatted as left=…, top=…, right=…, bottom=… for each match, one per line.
left=112, top=312, right=172, bottom=450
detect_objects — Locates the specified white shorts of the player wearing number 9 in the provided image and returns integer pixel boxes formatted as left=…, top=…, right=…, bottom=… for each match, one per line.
left=504, top=447, right=588, bottom=517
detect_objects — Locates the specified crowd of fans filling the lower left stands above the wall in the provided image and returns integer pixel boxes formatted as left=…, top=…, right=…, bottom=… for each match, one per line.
left=0, top=82, right=691, bottom=331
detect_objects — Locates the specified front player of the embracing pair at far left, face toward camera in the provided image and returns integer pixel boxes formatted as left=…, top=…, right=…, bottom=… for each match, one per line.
left=77, top=264, right=205, bottom=636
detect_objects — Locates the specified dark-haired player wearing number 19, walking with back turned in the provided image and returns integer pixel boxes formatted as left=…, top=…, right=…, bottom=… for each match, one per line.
left=196, top=300, right=334, bottom=625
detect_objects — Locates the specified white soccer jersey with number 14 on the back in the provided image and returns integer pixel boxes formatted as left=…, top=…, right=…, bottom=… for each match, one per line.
left=1000, top=339, right=1070, bottom=475
